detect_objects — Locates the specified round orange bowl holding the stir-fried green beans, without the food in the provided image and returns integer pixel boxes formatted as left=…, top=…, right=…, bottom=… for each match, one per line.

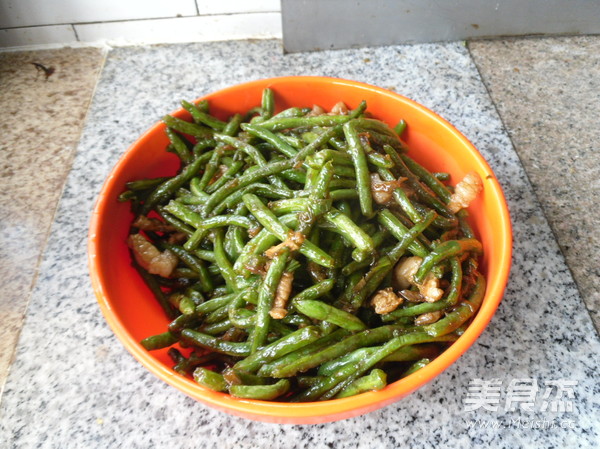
left=88, top=77, right=512, bottom=424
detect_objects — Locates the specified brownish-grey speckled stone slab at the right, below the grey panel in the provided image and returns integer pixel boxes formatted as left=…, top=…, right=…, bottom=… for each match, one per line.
left=469, top=36, right=600, bottom=329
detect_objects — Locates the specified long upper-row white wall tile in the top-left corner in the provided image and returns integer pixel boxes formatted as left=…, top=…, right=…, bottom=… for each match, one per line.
left=0, top=0, right=196, bottom=28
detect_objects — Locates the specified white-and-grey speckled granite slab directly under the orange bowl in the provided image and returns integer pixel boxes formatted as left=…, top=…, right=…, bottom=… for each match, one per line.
left=0, top=41, right=600, bottom=449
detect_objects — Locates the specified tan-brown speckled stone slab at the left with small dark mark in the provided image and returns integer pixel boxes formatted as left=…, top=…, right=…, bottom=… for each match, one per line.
left=0, top=48, right=104, bottom=391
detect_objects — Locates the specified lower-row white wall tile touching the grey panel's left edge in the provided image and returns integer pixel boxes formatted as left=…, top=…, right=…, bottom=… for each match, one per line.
left=75, top=13, right=281, bottom=45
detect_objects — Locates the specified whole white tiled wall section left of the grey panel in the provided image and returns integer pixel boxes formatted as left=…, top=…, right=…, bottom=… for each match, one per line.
left=0, top=0, right=282, bottom=48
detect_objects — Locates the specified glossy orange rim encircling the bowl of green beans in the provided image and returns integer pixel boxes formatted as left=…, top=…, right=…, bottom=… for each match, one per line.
left=88, top=76, right=512, bottom=424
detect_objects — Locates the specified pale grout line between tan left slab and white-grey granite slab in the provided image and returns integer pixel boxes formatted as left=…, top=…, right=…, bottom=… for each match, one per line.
left=0, top=49, right=110, bottom=403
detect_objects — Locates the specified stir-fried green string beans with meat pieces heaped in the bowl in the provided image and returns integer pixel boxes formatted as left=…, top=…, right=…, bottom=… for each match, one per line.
left=119, top=89, right=485, bottom=401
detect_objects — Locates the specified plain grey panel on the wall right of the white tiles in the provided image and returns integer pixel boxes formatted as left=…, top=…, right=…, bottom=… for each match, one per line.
left=281, top=0, right=600, bottom=52
